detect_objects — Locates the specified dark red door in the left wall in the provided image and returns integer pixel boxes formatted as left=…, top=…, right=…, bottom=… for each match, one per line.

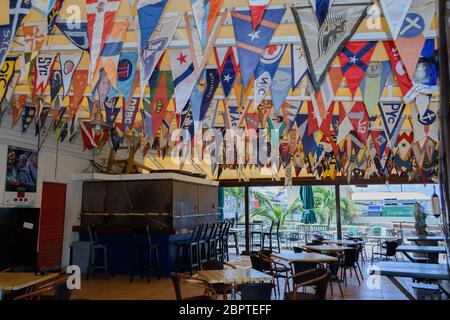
left=38, top=182, right=66, bottom=269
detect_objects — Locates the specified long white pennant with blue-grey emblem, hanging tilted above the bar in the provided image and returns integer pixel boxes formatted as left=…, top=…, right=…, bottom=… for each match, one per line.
left=139, top=14, right=181, bottom=98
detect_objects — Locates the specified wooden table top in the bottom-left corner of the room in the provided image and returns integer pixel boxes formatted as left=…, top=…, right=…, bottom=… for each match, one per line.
left=0, top=272, right=59, bottom=291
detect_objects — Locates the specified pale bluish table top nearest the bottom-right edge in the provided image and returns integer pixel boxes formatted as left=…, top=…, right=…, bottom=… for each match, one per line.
left=372, top=261, right=449, bottom=280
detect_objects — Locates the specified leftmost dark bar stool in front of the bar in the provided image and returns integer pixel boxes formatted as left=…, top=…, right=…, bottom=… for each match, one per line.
left=86, top=224, right=113, bottom=280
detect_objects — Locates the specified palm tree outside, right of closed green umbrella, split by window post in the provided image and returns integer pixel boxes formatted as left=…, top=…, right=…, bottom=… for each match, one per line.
left=314, top=187, right=359, bottom=229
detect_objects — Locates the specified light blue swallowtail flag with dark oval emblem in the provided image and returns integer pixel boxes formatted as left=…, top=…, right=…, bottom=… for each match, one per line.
left=108, top=51, right=138, bottom=101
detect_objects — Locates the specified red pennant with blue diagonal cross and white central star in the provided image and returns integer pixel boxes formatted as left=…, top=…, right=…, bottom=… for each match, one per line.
left=339, top=41, right=377, bottom=98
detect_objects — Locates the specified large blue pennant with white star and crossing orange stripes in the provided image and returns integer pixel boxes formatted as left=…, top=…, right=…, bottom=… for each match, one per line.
left=231, top=8, right=286, bottom=87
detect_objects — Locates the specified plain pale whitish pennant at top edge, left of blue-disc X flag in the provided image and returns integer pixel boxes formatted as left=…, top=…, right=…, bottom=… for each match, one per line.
left=380, top=0, right=412, bottom=40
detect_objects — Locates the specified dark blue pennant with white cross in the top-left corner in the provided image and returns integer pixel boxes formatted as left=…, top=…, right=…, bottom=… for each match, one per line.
left=0, top=0, right=31, bottom=70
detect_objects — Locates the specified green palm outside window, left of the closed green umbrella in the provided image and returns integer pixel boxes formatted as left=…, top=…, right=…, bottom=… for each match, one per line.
left=252, top=191, right=303, bottom=227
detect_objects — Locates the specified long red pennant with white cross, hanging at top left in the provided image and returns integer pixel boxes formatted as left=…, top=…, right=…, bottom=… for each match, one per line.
left=86, top=0, right=120, bottom=84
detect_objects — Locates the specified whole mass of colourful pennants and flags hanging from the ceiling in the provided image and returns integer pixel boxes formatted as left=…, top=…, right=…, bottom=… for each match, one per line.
left=0, top=0, right=439, bottom=185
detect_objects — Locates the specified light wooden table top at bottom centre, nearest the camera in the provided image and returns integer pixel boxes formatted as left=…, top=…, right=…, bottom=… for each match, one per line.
left=195, top=268, right=273, bottom=284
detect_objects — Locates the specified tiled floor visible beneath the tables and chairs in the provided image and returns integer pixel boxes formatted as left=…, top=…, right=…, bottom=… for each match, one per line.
left=72, top=252, right=442, bottom=300
